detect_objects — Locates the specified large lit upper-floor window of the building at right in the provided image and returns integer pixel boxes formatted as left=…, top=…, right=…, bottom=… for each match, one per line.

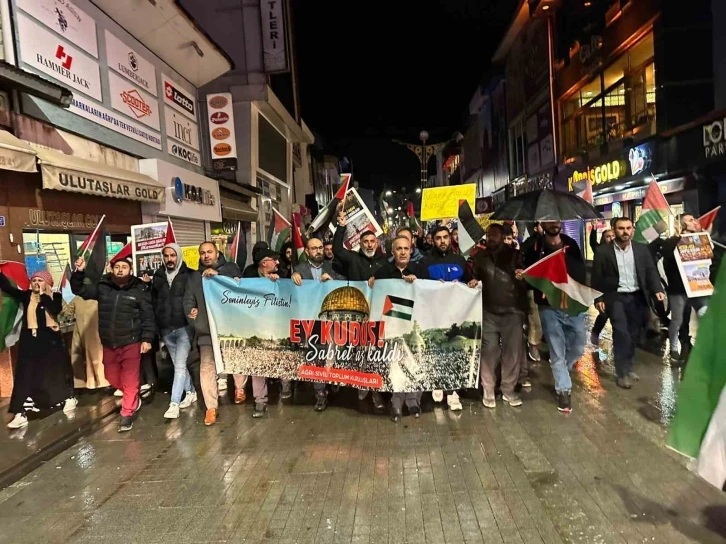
left=560, top=33, right=655, bottom=159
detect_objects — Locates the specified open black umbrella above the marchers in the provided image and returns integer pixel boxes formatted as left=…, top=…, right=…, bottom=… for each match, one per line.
left=491, top=189, right=602, bottom=221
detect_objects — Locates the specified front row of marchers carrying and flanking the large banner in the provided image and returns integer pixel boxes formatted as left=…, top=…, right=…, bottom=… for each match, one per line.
left=0, top=208, right=708, bottom=432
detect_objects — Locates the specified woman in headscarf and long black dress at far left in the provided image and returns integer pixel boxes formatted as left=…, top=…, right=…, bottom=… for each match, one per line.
left=0, top=270, right=78, bottom=429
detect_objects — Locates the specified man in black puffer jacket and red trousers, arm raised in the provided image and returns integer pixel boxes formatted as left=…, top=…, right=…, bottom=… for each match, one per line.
left=71, top=255, right=156, bottom=433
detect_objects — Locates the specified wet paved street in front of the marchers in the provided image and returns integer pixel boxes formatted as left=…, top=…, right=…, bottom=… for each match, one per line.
left=0, top=314, right=726, bottom=544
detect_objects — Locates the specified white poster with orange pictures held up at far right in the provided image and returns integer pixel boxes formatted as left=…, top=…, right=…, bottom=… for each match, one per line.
left=675, top=232, right=713, bottom=298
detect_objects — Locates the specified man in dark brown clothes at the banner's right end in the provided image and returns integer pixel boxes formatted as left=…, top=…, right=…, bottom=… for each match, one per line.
left=470, top=223, right=527, bottom=408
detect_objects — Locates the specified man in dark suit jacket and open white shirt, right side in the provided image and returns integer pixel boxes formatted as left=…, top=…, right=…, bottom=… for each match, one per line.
left=592, top=217, right=665, bottom=389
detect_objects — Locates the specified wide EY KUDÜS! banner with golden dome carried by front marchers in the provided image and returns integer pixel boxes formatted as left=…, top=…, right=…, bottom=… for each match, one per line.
left=203, top=276, right=481, bottom=392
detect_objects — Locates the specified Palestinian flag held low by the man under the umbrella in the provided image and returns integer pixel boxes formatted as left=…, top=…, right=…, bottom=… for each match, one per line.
left=524, top=249, right=602, bottom=315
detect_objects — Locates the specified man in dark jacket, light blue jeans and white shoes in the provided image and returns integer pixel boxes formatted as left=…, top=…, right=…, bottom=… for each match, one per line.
left=151, top=244, right=197, bottom=419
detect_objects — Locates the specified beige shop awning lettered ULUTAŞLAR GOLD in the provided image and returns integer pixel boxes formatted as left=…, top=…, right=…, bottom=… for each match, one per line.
left=35, top=148, right=166, bottom=202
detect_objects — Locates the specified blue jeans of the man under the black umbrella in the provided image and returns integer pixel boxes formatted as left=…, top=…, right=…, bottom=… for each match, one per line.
left=539, top=306, right=585, bottom=393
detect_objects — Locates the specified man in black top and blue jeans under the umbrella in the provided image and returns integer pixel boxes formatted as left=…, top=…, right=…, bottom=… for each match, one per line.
left=517, top=221, right=585, bottom=412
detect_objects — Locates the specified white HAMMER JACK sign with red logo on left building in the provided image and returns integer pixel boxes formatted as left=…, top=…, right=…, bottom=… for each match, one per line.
left=17, top=13, right=102, bottom=100
